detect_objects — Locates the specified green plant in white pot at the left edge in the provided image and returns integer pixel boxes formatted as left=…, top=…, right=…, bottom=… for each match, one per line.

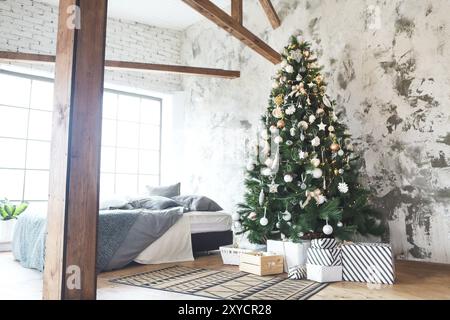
left=0, top=199, right=28, bottom=252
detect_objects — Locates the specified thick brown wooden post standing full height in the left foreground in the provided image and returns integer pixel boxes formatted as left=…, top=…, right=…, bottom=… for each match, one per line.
left=43, top=0, right=108, bottom=299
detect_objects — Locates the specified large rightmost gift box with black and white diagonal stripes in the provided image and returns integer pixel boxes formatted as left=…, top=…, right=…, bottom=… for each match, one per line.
left=342, top=243, right=395, bottom=284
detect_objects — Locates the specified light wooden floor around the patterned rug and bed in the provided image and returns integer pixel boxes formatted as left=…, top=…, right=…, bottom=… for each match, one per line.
left=0, top=253, right=450, bottom=300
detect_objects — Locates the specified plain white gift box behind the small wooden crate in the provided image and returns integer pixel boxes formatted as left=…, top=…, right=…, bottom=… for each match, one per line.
left=267, top=240, right=311, bottom=272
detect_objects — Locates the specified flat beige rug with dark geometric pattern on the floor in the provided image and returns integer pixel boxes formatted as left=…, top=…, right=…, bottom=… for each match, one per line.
left=111, top=266, right=326, bottom=300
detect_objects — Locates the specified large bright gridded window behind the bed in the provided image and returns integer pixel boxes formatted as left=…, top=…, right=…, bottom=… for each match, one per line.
left=0, top=71, right=162, bottom=202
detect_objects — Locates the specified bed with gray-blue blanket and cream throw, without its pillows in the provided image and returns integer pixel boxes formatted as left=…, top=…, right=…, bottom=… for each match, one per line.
left=13, top=206, right=233, bottom=272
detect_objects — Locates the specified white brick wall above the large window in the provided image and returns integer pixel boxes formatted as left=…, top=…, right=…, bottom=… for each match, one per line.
left=0, top=0, right=182, bottom=93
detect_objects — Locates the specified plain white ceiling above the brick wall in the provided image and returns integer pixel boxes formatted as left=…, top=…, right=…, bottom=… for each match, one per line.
left=39, top=0, right=231, bottom=30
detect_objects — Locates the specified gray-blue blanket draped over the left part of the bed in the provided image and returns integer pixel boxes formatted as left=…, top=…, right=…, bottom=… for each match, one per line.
left=13, top=207, right=185, bottom=272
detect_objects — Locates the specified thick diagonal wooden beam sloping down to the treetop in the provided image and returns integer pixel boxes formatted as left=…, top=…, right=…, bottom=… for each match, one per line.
left=182, top=0, right=281, bottom=64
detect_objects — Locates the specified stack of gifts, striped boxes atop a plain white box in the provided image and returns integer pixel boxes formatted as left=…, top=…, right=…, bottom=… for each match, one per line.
left=306, top=238, right=342, bottom=282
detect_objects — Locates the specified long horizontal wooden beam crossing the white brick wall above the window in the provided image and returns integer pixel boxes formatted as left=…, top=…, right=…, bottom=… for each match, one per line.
left=0, top=51, right=241, bottom=79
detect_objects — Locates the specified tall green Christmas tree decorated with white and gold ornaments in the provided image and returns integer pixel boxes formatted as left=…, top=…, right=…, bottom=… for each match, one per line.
left=235, top=35, right=384, bottom=244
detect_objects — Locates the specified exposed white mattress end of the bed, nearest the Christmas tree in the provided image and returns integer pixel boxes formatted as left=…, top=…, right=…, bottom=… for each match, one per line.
left=185, top=211, right=233, bottom=234
